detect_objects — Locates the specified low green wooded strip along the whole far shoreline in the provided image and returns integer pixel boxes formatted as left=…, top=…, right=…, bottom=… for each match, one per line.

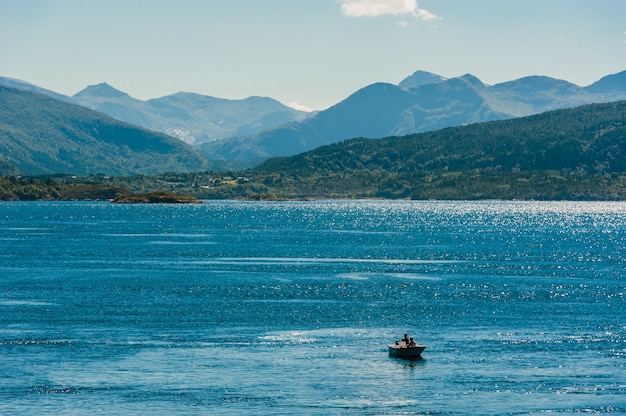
left=0, top=170, right=626, bottom=203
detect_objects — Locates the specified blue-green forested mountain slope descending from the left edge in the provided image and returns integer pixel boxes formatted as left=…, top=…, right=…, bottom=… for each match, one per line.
left=0, top=86, right=207, bottom=175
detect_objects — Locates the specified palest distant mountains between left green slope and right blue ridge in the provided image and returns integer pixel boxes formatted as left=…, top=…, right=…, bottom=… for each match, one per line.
left=72, top=84, right=309, bottom=144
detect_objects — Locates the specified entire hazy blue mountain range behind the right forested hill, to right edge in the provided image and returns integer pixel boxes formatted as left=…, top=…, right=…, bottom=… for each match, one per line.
left=200, top=71, right=626, bottom=161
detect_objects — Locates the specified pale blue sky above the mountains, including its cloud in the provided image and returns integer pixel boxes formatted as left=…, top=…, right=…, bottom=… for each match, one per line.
left=0, top=0, right=626, bottom=110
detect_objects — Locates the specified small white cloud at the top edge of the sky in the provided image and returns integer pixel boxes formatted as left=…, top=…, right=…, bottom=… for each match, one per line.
left=337, top=0, right=438, bottom=20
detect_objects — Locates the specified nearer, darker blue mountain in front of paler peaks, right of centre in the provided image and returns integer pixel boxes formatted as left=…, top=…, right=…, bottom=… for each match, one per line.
left=200, top=75, right=512, bottom=160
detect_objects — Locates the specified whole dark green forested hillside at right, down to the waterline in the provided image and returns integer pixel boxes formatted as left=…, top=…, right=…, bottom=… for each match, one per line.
left=246, top=101, right=626, bottom=199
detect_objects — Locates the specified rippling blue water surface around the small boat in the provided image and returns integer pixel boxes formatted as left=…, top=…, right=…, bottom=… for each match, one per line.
left=0, top=201, right=626, bottom=415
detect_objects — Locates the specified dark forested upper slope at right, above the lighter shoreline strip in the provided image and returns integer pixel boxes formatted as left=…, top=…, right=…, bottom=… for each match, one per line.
left=257, top=101, right=626, bottom=176
